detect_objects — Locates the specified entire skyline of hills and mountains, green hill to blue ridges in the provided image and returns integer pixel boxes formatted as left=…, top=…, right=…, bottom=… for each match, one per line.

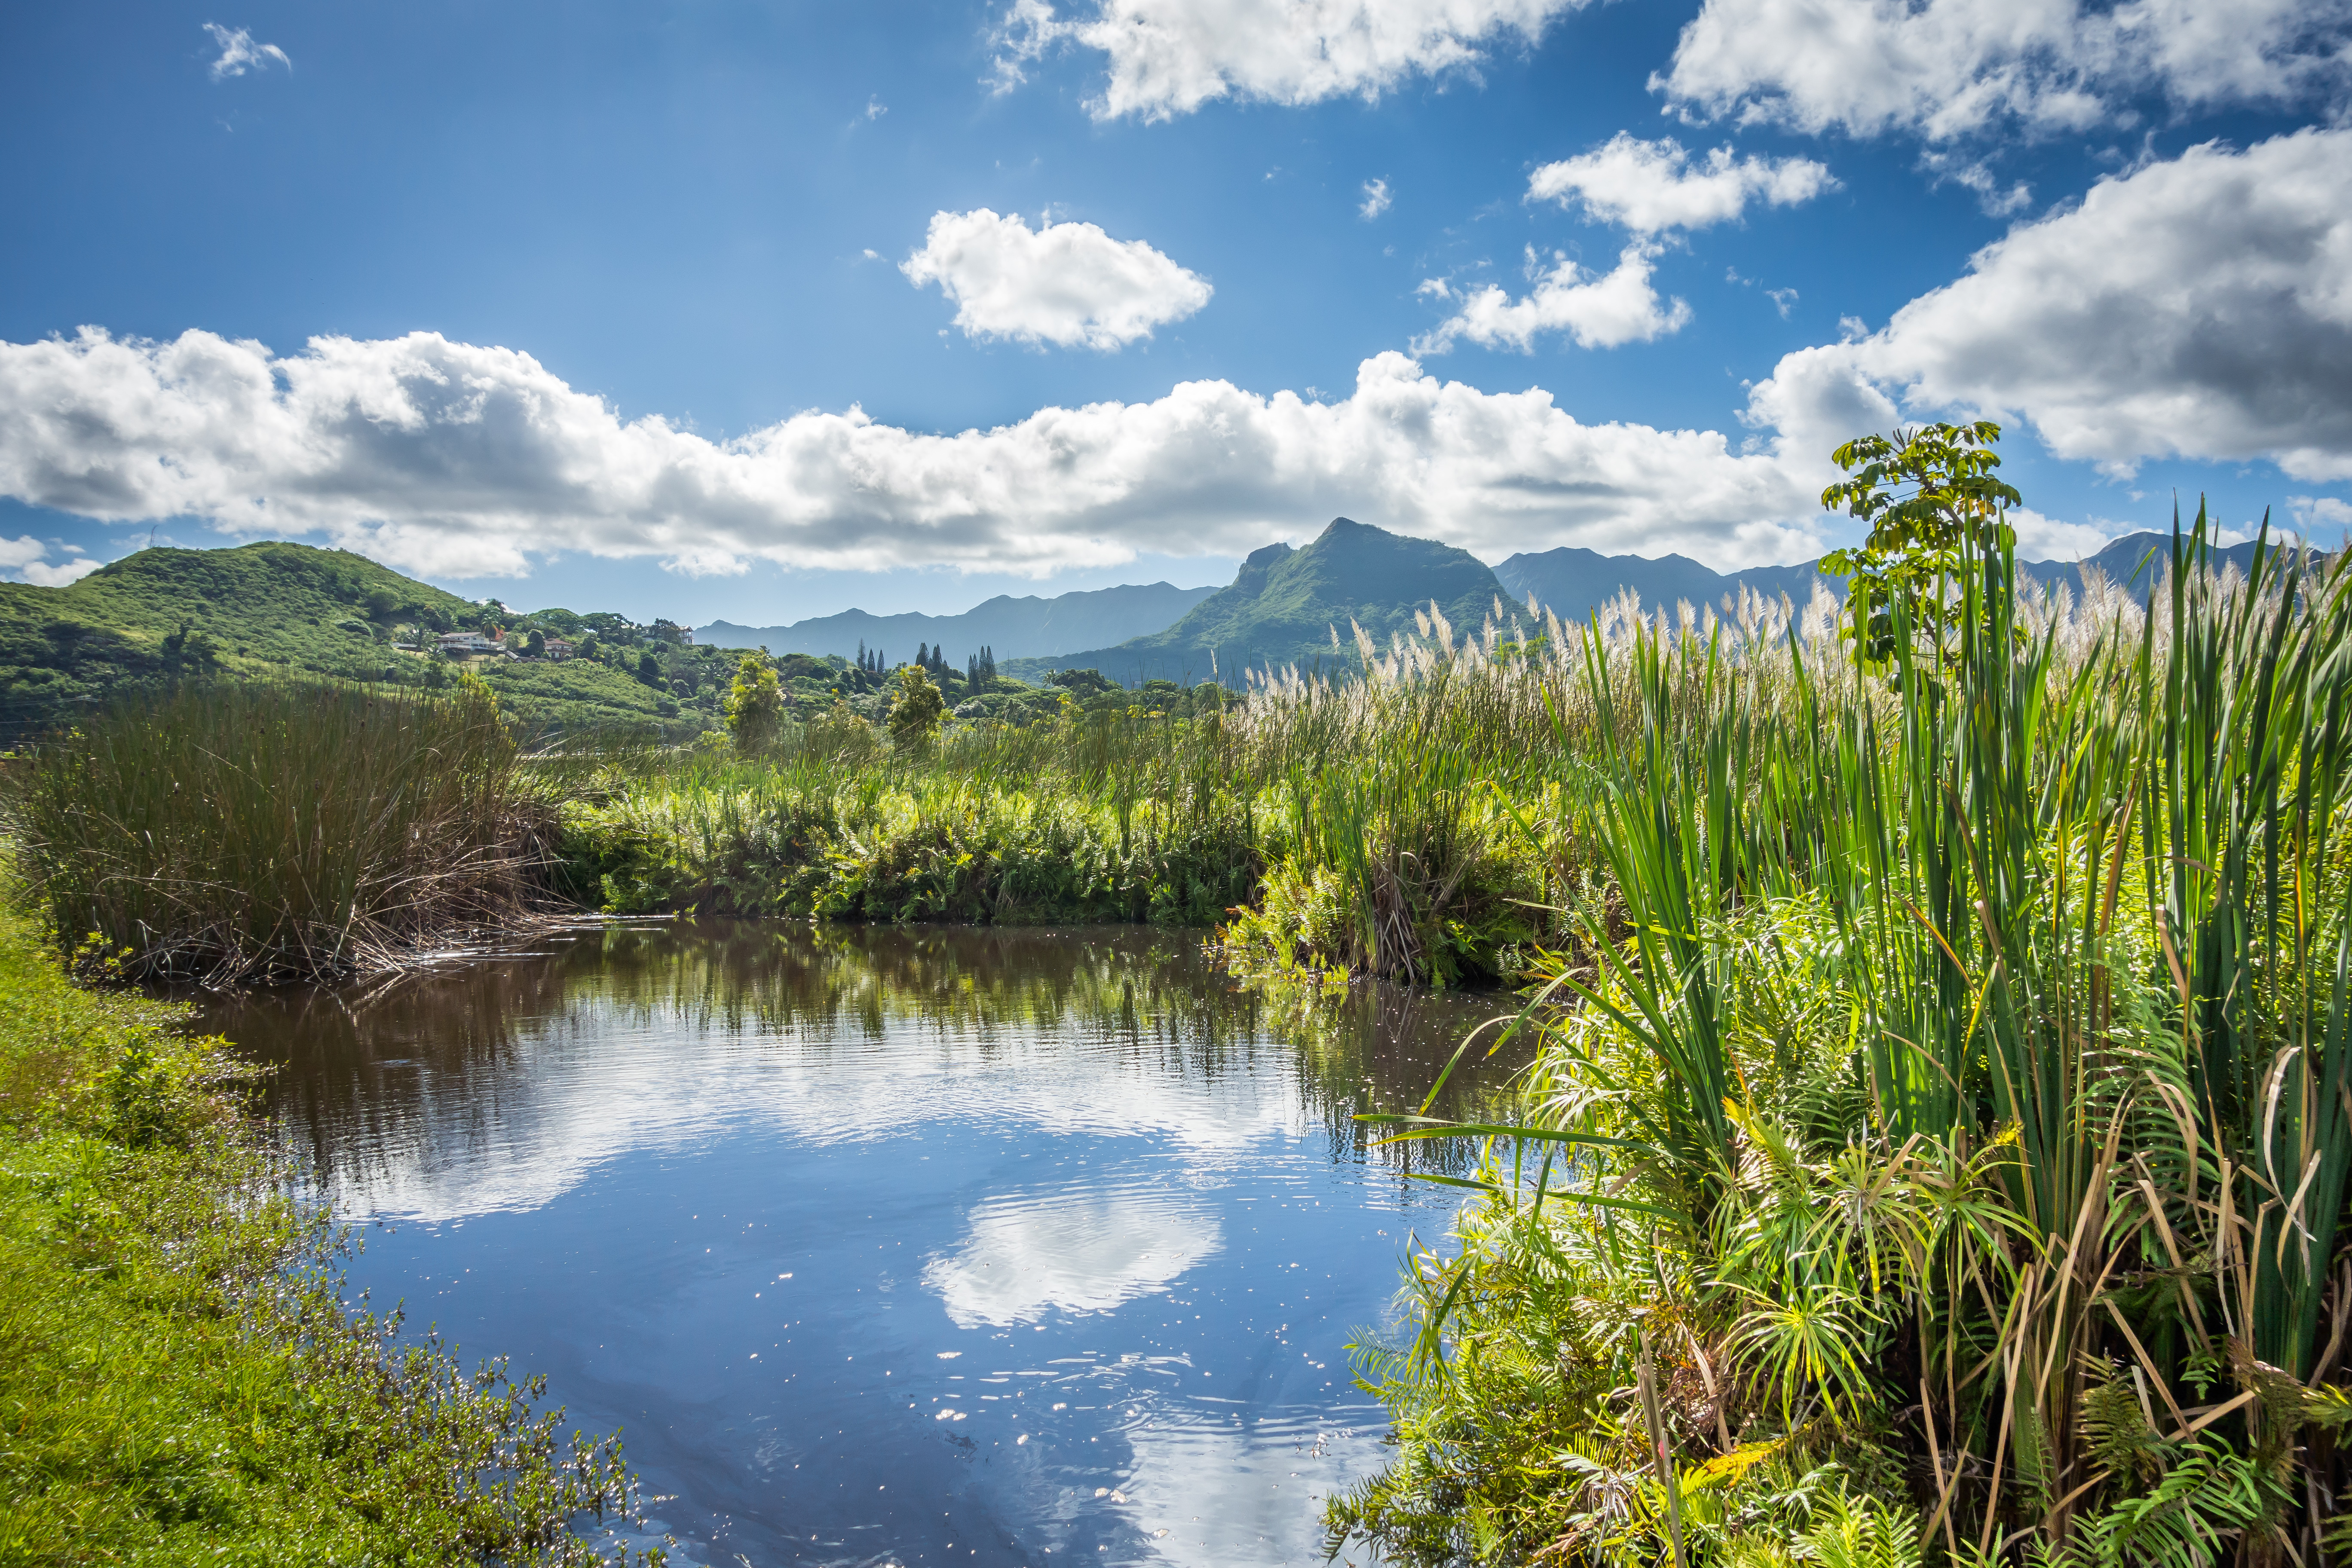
left=0, top=517, right=2253, bottom=743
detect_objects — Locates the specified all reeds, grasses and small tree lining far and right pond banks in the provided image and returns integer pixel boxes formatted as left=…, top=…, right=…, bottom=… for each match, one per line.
left=12, top=426, right=2352, bottom=1568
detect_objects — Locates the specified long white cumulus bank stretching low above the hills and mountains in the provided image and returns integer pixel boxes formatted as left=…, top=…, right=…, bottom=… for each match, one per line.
left=0, top=329, right=1818, bottom=576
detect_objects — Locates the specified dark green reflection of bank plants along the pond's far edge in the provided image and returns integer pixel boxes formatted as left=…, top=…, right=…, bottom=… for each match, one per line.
left=216, top=919, right=1491, bottom=1168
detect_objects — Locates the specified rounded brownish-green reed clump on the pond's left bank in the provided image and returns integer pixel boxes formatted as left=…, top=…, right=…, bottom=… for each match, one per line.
left=7, top=682, right=553, bottom=985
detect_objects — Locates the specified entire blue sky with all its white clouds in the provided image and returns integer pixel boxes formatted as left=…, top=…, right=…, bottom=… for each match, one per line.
left=0, top=0, right=2352, bottom=623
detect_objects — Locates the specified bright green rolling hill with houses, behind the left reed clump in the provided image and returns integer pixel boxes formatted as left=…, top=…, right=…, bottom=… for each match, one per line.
left=0, top=543, right=732, bottom=743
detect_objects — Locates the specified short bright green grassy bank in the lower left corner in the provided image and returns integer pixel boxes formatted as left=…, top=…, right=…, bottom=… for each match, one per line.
left=0, top=888, right=635, bottom=1568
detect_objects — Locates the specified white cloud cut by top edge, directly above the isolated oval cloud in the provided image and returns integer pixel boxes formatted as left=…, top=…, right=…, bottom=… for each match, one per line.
left=995, top=0, right=1588, bottom=120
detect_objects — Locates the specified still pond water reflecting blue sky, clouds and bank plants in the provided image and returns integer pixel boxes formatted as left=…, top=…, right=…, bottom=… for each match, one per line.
left=207, top=922, right=1512, bottom=1568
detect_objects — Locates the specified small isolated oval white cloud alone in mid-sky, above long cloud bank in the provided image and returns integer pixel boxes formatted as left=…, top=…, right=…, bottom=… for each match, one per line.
left=898, top=207, right=1211, bottom=350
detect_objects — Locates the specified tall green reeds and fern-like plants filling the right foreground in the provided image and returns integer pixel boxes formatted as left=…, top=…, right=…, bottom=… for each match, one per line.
left=1329, top=500, right=2352, bottom=1568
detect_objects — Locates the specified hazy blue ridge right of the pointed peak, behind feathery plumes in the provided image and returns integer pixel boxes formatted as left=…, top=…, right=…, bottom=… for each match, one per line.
left=1494, top=531, right=2253, bottom=621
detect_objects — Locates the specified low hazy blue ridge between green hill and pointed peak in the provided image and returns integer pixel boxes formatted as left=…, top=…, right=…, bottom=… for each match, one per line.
left=694, top=583, right=1216, bottom=665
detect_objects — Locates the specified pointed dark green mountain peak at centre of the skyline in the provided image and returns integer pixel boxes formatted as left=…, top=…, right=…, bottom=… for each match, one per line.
left=1000, top=517, right=1505, bottom=686
